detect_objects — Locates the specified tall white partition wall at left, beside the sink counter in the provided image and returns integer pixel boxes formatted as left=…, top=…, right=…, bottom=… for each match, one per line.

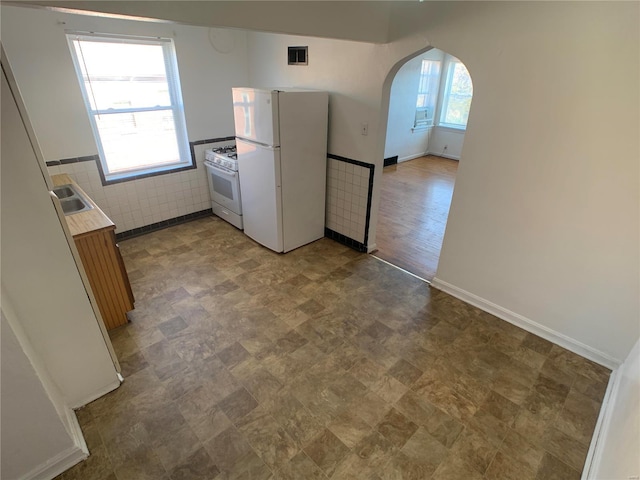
left=0, top=59, right=119, bottom=407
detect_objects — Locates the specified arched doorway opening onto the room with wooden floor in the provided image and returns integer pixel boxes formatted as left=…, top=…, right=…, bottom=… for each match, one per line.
left=373, top=49, right=473, bottom=281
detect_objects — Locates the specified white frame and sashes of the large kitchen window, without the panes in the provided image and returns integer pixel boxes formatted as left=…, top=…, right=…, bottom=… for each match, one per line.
left=66, top=31, right=196, bottom=185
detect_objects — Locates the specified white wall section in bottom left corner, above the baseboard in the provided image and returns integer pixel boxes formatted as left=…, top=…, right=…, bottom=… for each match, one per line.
left=0, top=312, right=84, bottom=480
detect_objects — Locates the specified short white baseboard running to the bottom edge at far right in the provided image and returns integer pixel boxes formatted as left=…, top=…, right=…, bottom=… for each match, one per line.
left=580, top=369, right=622, bottom=480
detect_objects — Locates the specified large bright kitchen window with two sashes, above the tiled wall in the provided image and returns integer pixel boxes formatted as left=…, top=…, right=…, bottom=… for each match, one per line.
left=67, top=33, right=195, bottom=184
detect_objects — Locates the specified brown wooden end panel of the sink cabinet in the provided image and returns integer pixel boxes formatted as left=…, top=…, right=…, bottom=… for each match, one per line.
left=73, top=227, right=133, bottom=330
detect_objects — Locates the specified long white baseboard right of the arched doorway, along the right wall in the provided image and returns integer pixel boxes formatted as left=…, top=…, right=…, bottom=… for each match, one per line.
left=431, top=277, right=622, bottom=370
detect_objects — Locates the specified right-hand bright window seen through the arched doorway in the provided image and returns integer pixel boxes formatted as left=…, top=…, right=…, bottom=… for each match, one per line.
left=439, top=59, right=473, bottom=129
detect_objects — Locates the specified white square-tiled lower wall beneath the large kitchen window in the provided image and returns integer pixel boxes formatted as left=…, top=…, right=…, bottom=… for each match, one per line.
left=48, top=140, right=234, bottom=233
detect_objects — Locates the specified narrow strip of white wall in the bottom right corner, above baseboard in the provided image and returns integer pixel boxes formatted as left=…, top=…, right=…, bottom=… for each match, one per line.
left=590, top=340, right=640, bottom=480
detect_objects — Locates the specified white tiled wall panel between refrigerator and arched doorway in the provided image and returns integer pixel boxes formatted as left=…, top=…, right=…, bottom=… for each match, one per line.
left=326, top=158, right=370, bottom=243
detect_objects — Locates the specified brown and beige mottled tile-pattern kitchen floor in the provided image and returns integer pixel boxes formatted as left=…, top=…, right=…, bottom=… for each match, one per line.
left=60, top=217, right=609, bottom=480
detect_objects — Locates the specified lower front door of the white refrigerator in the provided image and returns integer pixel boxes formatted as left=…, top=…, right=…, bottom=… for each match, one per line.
left=236, top=139, right=283, bottom=252
